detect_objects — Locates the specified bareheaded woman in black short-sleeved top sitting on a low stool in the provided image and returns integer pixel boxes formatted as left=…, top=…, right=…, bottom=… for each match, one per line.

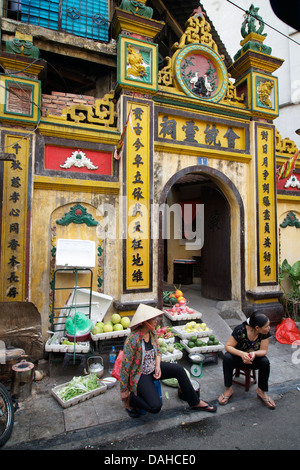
left=219, top=312, right=275, bottom=409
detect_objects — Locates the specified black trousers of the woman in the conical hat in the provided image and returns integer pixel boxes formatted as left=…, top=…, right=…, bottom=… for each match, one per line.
left=129, top=362, right=199, bottom=413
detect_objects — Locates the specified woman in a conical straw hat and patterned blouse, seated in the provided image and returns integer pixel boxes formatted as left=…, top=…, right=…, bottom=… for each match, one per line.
left=120, top=304, right=216, bottom=418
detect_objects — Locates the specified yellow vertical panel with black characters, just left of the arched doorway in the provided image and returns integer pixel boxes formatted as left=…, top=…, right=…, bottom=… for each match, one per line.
left=123, top=100, right=153, bottom=292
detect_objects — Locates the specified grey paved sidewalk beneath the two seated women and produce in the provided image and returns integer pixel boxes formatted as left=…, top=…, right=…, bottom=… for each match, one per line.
left=2, top=285, right=300, bottom=450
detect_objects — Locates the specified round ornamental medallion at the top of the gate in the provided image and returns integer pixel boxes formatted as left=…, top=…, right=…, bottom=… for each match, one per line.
left=175, top=44, right=228, bottom=102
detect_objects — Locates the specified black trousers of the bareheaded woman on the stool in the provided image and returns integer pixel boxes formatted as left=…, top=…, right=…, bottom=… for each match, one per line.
left=223, top=352, right=270, bottom=392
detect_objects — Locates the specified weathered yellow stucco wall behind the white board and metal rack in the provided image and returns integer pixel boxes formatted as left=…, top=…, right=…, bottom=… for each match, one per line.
left=30, top=189, right=122, bottom=333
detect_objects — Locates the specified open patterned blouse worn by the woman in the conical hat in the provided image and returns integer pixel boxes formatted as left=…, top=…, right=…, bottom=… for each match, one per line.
left=120, top=330, right=161, bottom=394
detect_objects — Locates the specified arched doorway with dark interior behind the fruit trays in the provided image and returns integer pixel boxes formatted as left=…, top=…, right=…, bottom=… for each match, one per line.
left=158, top=165, right=245, bottom=308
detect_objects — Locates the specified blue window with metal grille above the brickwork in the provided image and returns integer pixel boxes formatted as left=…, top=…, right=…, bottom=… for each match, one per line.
left=8, top=0, right=109, bottom=42
